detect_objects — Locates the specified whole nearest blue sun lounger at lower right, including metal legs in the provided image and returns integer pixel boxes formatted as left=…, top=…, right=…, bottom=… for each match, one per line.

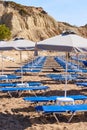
left=35, top=104, right=87, bottom=122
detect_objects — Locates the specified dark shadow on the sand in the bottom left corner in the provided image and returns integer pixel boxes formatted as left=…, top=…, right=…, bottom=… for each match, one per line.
left=0, top=112, right=31, bottom=130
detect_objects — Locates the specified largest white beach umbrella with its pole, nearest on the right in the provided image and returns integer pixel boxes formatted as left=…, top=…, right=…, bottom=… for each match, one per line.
left=36, top=31, right=87, bottom=97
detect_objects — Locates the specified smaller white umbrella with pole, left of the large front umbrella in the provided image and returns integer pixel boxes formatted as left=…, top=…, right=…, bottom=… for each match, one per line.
left=0, top=39, right=35, bottom=83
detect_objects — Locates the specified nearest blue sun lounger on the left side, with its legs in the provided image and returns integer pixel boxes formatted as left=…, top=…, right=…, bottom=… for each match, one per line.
left=0, top=86, right=49, bottom=97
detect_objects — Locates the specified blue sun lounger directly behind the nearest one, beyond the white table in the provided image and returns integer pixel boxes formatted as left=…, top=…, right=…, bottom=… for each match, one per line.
left=23, top=95, right=87, bottom=103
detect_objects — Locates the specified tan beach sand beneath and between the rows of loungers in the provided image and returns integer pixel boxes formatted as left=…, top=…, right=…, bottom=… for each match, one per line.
left=0, top=51, right=87, bottom=130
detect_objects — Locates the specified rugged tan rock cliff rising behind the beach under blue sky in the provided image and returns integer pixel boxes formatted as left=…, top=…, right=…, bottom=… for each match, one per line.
left=0, top=1, right=87, bottom=41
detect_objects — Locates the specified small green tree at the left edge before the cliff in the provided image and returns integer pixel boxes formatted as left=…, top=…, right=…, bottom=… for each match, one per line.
left=0, top=24, right=11, bottom=40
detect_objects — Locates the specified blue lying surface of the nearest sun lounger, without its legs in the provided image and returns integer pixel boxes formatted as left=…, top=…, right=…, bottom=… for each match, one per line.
left=35, top=104, right=87, bottom=113
